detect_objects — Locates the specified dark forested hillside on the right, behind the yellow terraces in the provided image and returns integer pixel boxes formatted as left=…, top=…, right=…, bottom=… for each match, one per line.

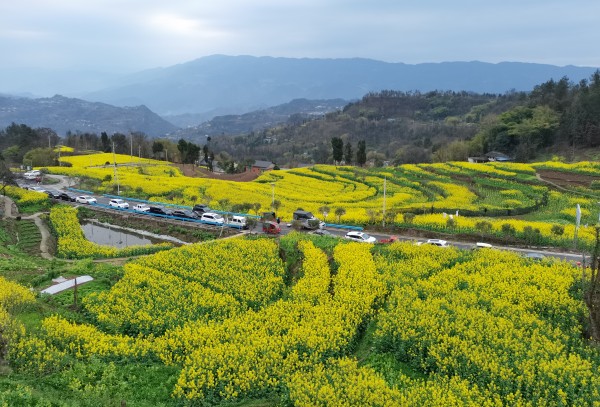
left=212, top=72, right=600, bottom=165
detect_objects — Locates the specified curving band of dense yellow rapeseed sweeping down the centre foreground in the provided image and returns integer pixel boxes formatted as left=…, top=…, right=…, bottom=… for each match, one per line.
left=163, top=243, right=385, bottom=401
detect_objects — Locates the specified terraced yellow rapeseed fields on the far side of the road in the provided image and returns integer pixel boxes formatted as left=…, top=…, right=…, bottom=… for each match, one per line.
left=43, top=154, right=568, bottom=223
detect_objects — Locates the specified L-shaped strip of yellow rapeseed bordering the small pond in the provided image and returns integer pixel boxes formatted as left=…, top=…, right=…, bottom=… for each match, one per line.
left=50, top=206, right=172, bottom=259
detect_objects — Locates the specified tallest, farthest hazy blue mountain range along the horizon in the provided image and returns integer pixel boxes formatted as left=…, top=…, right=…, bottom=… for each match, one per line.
left=81, top=55, right=597, bottom=116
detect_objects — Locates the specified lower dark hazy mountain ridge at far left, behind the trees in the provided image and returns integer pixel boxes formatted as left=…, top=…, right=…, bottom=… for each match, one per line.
left=0, top=95, right=177, bottom=136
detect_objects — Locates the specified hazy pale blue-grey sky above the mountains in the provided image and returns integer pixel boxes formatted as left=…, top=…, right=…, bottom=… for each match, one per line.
left=0, top=0, right=600, bottom=73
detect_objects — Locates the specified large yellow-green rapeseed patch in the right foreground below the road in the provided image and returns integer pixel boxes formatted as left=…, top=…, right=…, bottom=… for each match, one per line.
left=375, top=250, right=600, bottom=405
